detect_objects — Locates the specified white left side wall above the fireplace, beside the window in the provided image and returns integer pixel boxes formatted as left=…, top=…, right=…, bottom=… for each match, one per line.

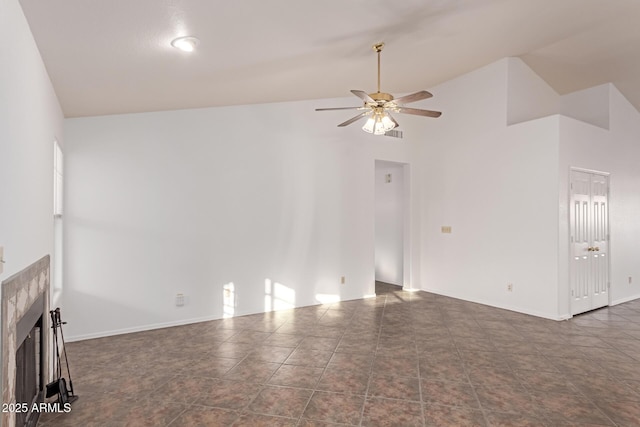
left=0, top=0, right=62, bottom=424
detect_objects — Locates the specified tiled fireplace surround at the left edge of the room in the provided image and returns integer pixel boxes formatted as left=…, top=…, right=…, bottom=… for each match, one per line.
left=0, top=255, right=50, bottom=426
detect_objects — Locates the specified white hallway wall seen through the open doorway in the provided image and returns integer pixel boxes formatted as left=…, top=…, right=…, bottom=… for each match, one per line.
left=375, top=161, right=405, bottom=286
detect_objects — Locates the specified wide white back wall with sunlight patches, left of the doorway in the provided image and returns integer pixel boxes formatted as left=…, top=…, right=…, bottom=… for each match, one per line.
left=64, top=99, right=420, bottom=339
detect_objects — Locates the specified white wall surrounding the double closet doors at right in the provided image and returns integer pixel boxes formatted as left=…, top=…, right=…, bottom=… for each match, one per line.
left=559, top=84, right=640, bottom=315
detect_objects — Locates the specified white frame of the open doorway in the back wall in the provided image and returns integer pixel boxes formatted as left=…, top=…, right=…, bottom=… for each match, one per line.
left=372, top=158, right=417, bottom=293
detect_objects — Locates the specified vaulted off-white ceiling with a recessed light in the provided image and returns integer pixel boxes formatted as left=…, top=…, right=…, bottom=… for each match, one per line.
left=21, top=0, right=640, bottom=117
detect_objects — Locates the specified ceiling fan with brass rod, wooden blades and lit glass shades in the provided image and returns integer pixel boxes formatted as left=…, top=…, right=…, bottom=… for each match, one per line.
left=316, top=42, right=442, bottom=135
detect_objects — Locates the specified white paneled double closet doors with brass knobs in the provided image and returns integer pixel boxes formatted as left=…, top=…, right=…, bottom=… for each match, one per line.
left=569, top=170, right=609, bottom=315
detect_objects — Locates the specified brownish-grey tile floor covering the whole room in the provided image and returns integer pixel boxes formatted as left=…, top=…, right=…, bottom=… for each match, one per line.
left=39, top=284, right=640, bottom=427
